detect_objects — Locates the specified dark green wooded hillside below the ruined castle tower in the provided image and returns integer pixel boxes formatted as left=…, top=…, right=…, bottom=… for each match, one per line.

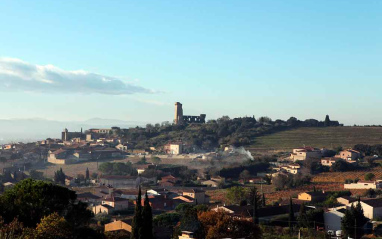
left=120, top=116, right=340, bottom=149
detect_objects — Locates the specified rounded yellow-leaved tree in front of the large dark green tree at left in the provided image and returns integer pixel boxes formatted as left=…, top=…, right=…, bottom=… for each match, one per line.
left=35, top=213, right=72, bottom=239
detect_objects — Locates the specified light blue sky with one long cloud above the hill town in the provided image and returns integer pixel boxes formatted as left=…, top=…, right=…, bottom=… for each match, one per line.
left=0, top=0, right=382, bottom=125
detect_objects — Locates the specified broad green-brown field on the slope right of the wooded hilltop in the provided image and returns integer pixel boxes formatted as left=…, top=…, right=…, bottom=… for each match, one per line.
left=246, top=127, right=382, bottom=150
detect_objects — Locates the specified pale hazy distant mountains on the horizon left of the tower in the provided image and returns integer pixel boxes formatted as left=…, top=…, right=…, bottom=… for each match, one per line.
left=0, top=118, right=146, bottom=144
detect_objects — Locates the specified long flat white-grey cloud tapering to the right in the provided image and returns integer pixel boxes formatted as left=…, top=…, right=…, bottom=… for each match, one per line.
left=0, top=57, right=154, bottom=95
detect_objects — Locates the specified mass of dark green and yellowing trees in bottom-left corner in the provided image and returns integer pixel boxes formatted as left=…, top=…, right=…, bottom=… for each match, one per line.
left=0, top=179, right=100, bottom=238
